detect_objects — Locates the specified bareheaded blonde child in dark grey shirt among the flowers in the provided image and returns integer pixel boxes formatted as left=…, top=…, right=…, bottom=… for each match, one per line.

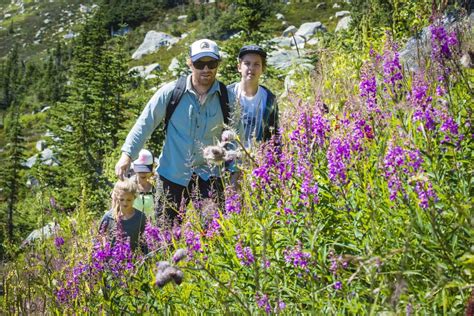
left=99, top=178, right=146, bottom=252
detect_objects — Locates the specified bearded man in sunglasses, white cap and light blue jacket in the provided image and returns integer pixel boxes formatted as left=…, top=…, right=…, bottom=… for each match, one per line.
left=115, top=39, right=231, bottom=221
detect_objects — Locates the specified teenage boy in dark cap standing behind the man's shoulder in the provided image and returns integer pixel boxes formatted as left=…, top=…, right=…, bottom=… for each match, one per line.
left=227, top=45, right=278, bottom=148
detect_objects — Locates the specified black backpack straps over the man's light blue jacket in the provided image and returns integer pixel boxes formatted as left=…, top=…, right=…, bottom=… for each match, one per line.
left=163, top=76, right=230, bottom=133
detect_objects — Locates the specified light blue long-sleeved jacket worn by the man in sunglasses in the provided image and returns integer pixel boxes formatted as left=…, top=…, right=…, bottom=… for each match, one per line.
left=122, top=75, right=235, bottom=186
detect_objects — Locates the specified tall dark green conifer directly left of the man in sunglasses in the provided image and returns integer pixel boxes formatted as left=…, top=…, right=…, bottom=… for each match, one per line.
left=51, top=11, right=128, bottom=211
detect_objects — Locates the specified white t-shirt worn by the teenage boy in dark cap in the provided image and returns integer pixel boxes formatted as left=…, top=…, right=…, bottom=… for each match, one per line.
left=235, top=84, right=267, bottom=148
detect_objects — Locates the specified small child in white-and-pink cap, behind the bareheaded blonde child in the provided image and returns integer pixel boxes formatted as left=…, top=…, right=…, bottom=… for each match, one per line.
left=132, top=149, right=156, bottom=218
